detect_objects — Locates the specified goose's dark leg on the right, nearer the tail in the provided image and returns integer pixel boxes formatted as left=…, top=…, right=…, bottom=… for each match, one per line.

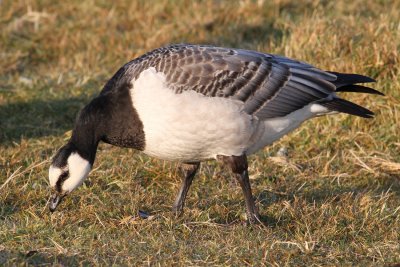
left=218, top=155, right=261, bottom=224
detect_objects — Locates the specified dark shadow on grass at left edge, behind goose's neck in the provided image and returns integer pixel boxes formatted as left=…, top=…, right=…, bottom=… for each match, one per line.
left=0, top=98, right=88, bottom=145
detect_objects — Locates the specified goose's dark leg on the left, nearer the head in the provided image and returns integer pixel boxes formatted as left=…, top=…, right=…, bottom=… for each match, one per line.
left=172, top=162, right=200, bottom=216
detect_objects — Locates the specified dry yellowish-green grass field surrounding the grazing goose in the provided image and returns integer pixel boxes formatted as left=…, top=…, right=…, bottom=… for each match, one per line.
left=0, top=0, right=400, bottom=266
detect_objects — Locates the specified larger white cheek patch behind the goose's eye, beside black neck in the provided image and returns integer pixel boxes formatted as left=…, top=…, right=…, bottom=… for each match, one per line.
left=62, top=153, right=92, bottom=192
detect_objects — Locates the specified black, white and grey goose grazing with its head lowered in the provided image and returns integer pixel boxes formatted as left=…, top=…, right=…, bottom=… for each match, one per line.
left=49, top=44, right=383, bottom=223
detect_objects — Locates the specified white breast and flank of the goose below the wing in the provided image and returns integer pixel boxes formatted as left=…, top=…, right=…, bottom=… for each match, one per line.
left=131, top=68, right=259, bottom=161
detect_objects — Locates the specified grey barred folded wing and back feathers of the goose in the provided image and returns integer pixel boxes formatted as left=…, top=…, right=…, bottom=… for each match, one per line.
left=102, top=44, right=372, bottom=119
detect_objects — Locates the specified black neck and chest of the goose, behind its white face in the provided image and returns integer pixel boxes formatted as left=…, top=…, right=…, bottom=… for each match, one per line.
left=71, top=85, right=145, bottom=165
